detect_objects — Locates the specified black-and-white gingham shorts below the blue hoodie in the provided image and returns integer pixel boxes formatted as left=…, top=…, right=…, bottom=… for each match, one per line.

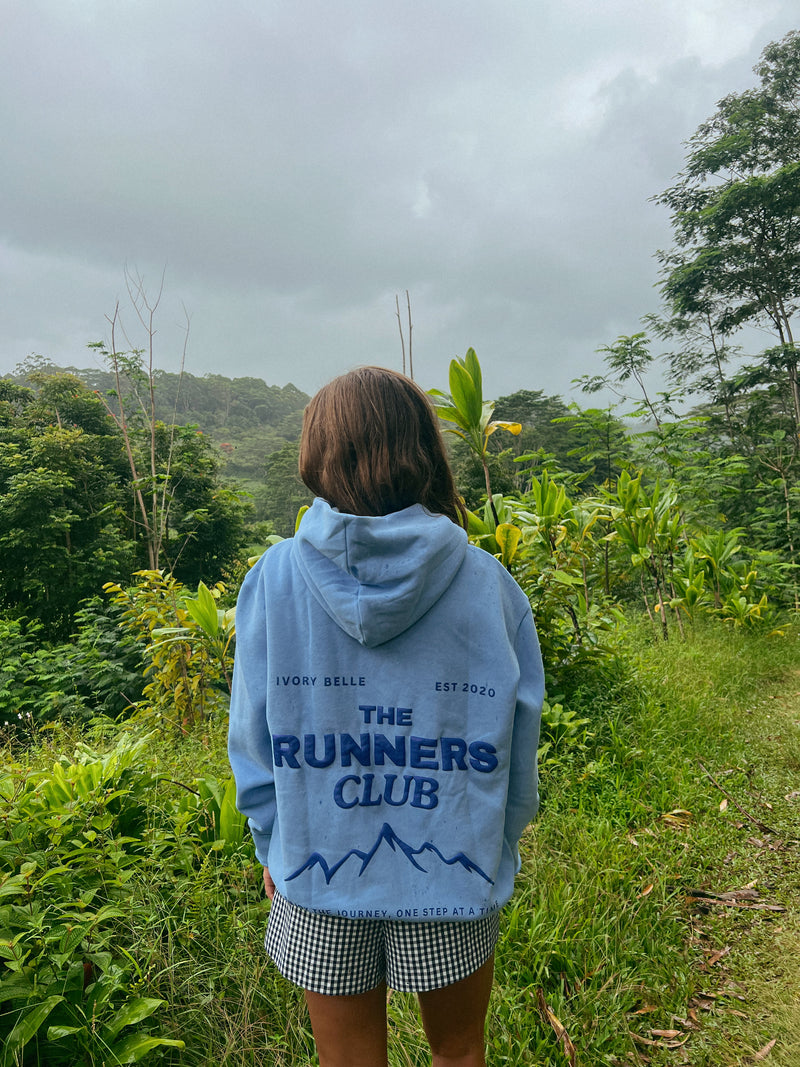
left=265, top=893, right=500, bottom=997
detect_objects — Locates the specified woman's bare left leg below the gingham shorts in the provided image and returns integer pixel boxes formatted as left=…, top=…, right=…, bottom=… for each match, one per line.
left=305, top=984, right=388, bottom=1067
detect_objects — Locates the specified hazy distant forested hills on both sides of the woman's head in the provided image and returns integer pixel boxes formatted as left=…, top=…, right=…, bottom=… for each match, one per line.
left=7, top=356, right=626, bottom=537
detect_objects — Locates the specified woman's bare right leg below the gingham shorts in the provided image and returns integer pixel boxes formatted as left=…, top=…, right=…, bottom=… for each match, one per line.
left=418, top=956, right=495, bottom=1067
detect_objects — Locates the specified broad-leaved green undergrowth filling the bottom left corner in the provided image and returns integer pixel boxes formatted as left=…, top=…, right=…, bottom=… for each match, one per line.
left=0, top=733, right=244, bottom=1067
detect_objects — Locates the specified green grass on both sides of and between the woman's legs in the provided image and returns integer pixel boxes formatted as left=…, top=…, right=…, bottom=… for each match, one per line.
left=3, top=624, right=800, bottom=1067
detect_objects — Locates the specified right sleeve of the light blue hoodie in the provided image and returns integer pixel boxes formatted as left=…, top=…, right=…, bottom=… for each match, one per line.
left=506, top=609, right=544, bottom=848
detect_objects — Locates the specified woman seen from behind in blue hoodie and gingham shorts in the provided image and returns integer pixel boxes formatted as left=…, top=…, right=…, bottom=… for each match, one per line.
left=229, top=367, right=543, bottom=1067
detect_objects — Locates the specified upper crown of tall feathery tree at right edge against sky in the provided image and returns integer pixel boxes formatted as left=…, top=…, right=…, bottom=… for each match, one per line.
left=656, top=31, right=800, bottom=433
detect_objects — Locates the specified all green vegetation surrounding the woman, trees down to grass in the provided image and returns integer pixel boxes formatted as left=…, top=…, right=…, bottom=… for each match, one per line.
left=0, top=33, right=800, bottom=1067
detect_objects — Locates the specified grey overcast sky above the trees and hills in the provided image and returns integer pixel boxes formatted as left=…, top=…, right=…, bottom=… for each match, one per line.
left=0, top=0, right=800, bottom=398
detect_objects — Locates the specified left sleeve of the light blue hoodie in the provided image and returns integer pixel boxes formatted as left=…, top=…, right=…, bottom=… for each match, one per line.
left=228, top=564, right=275, bottom=866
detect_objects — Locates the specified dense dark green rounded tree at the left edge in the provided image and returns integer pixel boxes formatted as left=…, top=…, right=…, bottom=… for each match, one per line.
left=0, top=375, right=133, bottom=636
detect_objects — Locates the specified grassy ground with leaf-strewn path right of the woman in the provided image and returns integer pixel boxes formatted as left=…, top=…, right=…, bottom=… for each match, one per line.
left=480, top=632, right=800, bottom=1067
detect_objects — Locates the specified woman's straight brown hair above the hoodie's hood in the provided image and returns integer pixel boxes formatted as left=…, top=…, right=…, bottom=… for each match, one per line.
left=300, top=367, right=466, bottom=526
